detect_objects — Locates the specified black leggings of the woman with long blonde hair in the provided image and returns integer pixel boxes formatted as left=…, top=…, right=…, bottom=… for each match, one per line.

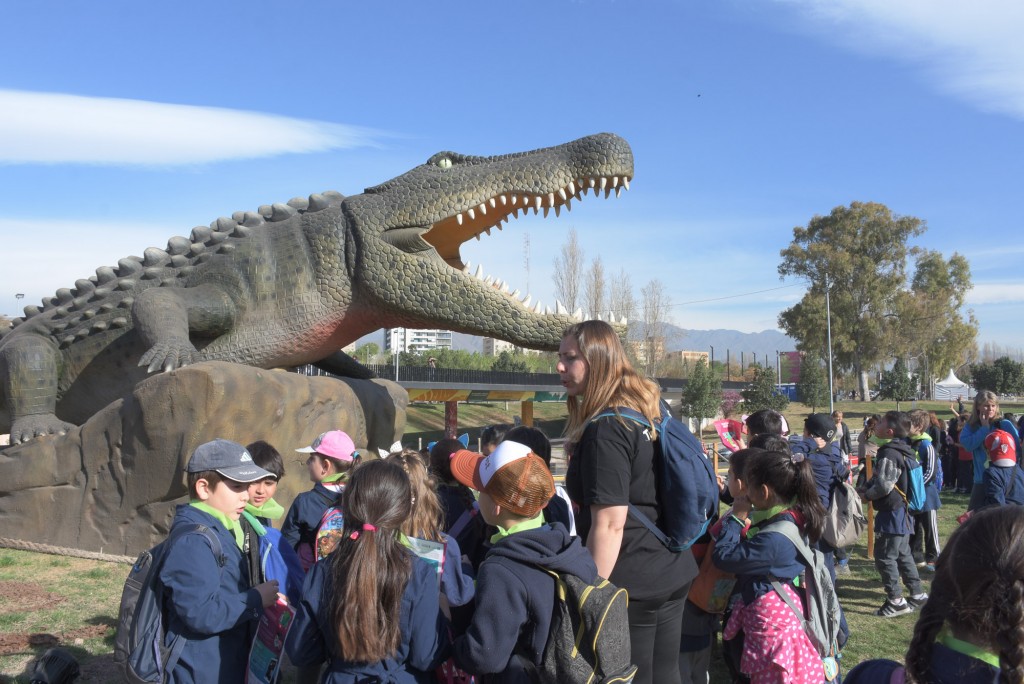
left=629, top=584, right=690, bottom=684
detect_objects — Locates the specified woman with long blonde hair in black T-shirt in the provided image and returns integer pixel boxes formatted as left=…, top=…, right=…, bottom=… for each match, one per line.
left=558, top=320, right=697, bottom=684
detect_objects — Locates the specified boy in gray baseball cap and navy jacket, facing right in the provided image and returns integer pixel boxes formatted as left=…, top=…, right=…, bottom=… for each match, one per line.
left=160, top=439, right=278, bottom=683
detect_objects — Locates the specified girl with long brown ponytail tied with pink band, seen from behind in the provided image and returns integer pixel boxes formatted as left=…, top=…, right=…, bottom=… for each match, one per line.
left=286, top=461, right=446, bottom=684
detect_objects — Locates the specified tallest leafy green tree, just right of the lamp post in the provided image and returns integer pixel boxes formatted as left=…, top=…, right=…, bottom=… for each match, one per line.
left=778, top=202, right=926, bottom=397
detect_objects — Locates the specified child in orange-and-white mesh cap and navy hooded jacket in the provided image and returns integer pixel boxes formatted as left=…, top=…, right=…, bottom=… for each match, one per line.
left=450, top=441, right=597, bottom=683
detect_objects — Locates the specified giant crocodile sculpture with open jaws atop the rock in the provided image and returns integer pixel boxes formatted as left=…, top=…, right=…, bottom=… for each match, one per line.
left=0, top=133, right=633, bottom=443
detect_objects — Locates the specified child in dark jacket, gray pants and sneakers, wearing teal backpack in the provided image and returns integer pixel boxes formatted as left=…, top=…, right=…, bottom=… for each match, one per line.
left=857, top=411, right=928, bottom=617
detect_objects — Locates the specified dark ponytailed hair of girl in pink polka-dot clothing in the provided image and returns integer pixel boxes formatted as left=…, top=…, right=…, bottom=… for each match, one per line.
left=744, top=452, right=825, bottom=544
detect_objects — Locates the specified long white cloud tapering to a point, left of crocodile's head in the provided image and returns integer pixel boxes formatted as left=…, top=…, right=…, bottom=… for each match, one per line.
left=0, top=90, right=381, bottom=166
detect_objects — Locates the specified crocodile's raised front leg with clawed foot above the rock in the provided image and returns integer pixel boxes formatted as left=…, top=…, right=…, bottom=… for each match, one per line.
left=131, top=285, right=238, bottom=373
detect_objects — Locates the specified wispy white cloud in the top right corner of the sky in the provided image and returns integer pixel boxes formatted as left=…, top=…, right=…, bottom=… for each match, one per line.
left=782, top=0, right=1024, bottom=119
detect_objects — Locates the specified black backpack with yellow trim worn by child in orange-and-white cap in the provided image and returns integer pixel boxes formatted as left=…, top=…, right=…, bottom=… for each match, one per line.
left=538, top=568, right=637, bottom=684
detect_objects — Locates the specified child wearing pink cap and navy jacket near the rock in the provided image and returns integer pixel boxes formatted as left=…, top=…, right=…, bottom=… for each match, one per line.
left=281, top=430, right=360, bottom=571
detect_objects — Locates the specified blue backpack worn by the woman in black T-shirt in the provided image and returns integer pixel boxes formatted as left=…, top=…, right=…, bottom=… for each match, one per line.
left=594, top=401, right=719, bottom=553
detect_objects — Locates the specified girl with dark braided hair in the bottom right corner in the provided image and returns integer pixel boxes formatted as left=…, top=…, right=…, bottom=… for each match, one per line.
left=845, top=506, right=1024, bottom=684
